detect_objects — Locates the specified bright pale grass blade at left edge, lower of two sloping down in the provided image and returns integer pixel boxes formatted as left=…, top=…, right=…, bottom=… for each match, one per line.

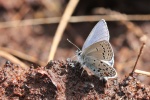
left=0, top=50, right=29, bottom=69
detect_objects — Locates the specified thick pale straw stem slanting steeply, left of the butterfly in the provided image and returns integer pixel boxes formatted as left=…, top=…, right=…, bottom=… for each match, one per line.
left=48, top=0, right=79, bottom=62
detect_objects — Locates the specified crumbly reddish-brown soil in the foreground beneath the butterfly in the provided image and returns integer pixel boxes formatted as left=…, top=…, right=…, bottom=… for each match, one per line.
left=0, top=61, right=150, bottom=100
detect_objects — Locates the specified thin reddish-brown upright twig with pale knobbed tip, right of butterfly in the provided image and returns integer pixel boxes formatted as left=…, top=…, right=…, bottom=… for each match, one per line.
left=131, top=35, right=147, bottom=74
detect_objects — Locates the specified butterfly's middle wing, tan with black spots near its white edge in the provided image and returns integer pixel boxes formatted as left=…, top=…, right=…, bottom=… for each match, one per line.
left=82, top=40, right=114, bottom=67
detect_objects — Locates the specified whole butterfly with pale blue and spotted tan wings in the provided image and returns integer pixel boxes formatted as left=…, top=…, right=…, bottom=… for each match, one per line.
left=68, top=19, right=117, bottom=80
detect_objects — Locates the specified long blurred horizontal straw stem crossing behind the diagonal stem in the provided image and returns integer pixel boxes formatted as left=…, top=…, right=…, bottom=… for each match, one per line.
left=0, top=14, right=150, bottom=28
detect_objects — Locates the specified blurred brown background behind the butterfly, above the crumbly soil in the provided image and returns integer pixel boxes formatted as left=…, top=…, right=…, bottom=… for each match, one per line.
left=0, top=0, right=150, bottom=84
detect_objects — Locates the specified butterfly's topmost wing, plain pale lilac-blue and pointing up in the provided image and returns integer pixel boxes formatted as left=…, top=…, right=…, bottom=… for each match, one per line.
left=82, top=19, right=109, bottom=51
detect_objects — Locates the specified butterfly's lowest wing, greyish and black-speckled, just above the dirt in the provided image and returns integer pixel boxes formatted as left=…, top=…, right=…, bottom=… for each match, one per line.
left=84, top=56, right=117, bottom=78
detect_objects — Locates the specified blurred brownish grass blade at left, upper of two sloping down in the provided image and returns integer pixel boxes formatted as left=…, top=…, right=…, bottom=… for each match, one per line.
left=0, top=47, right=46, bottom=66
